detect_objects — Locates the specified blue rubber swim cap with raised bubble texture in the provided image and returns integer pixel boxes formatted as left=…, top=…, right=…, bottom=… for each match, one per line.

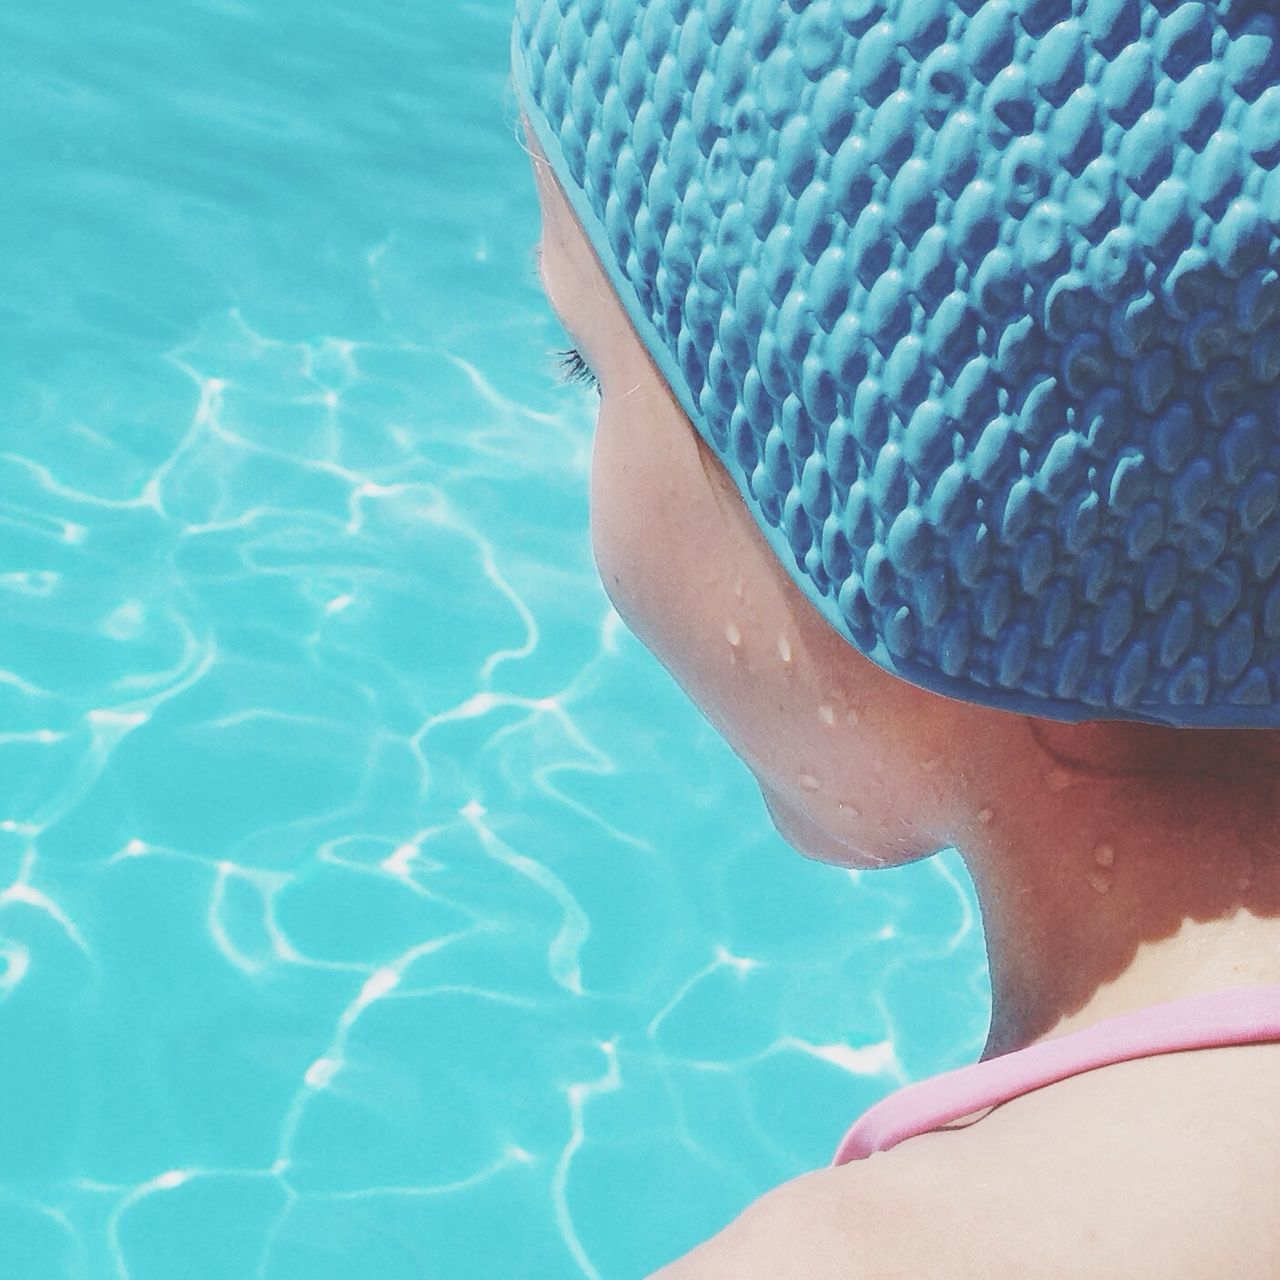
left=515, top=0, right=1280, bottom=726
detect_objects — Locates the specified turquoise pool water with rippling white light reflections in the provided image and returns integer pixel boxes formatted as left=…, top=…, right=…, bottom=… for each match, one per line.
left=0, top=0, right=987, bottom=1280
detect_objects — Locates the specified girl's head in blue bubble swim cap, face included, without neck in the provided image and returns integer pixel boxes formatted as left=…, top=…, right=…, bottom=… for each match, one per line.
left=516, top=0, right=1280, bottom=863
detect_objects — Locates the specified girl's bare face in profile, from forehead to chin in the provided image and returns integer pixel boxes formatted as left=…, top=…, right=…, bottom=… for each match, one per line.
left=534, top=145, right=960, bottom=864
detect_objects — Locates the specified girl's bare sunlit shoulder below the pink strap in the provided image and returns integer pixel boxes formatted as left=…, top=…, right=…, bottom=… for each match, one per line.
left=653, top=1046, right=1280, bottom=1280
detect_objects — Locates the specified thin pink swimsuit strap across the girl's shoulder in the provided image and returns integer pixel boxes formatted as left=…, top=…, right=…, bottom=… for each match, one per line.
left=832, top=987, right=1280, bottom=1165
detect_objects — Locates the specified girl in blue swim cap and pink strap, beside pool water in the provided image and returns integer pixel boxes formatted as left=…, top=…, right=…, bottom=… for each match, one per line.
left=513, top=0, right=1280, bottom=1280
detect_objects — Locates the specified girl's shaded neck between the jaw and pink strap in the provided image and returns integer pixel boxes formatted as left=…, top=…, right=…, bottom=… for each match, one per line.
left=957, top=721, right=1280, bottom=1057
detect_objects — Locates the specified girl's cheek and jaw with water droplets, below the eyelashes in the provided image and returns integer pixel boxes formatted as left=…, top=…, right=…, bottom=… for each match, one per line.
left=591, top=396, right=936, bottom=867
